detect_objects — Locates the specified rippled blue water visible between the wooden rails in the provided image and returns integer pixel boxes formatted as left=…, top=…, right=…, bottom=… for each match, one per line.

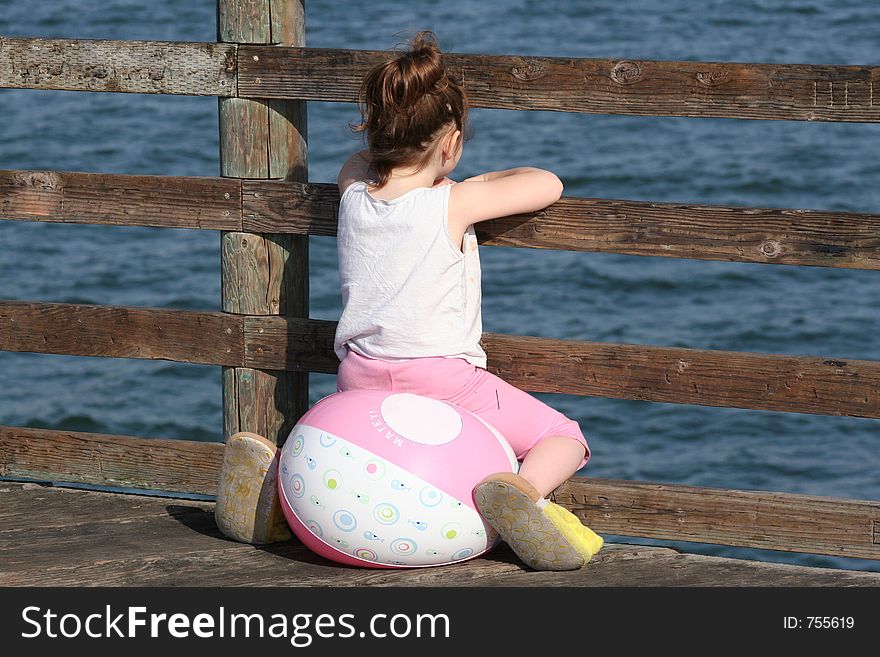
left=0, top=0, right=880, bottom=571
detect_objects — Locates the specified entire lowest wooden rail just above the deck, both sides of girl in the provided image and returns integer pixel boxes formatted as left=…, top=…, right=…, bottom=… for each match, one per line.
left=0, top=426, right=880, bottom=559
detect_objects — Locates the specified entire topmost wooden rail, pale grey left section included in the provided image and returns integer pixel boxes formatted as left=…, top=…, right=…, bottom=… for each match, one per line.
left=0, top=37, right=880, bottom=122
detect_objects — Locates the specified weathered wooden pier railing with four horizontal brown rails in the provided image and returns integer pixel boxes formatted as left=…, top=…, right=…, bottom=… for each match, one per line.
left=0, top=20, right=880, bottom=559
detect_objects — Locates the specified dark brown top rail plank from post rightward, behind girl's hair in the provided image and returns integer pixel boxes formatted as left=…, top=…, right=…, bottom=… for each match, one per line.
left=238, top=46, right=880, bottom=122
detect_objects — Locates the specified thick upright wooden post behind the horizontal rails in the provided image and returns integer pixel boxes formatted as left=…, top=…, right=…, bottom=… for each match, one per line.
left=217, top=0, right=309, bottom=444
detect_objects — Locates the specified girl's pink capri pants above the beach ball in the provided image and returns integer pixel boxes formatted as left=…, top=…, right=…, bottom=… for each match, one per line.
left=336, top=349, right=590, bottom=468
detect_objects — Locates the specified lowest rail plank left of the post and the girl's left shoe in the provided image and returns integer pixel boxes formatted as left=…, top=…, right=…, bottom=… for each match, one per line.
left=0, top=426, right=223, bottom=495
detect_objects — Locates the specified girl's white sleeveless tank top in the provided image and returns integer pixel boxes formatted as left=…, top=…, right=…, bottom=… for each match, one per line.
left=333, top=180, right=486, bottom=369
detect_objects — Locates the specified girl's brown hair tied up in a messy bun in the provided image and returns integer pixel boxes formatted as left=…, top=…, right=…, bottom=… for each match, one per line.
left=350, top=30, right=471, bottom=187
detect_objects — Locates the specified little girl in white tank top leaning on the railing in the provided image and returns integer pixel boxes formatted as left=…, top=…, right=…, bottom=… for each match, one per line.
left=218, top=30, right=603, bottom=570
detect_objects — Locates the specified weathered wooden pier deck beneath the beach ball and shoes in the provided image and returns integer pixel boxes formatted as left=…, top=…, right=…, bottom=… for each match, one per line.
left=0, top=482, right=880, bottom=587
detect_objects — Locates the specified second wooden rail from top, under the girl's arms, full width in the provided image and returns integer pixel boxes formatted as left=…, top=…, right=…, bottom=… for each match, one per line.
left=0, top=170, right=880, bottom=270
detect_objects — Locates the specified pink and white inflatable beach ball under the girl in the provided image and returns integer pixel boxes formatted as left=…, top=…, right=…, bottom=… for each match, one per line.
left=278, top=390, right=517, bottom=568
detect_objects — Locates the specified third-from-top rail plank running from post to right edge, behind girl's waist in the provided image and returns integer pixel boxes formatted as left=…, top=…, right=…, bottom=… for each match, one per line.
left=244, top=317, right=880, bottom=418
